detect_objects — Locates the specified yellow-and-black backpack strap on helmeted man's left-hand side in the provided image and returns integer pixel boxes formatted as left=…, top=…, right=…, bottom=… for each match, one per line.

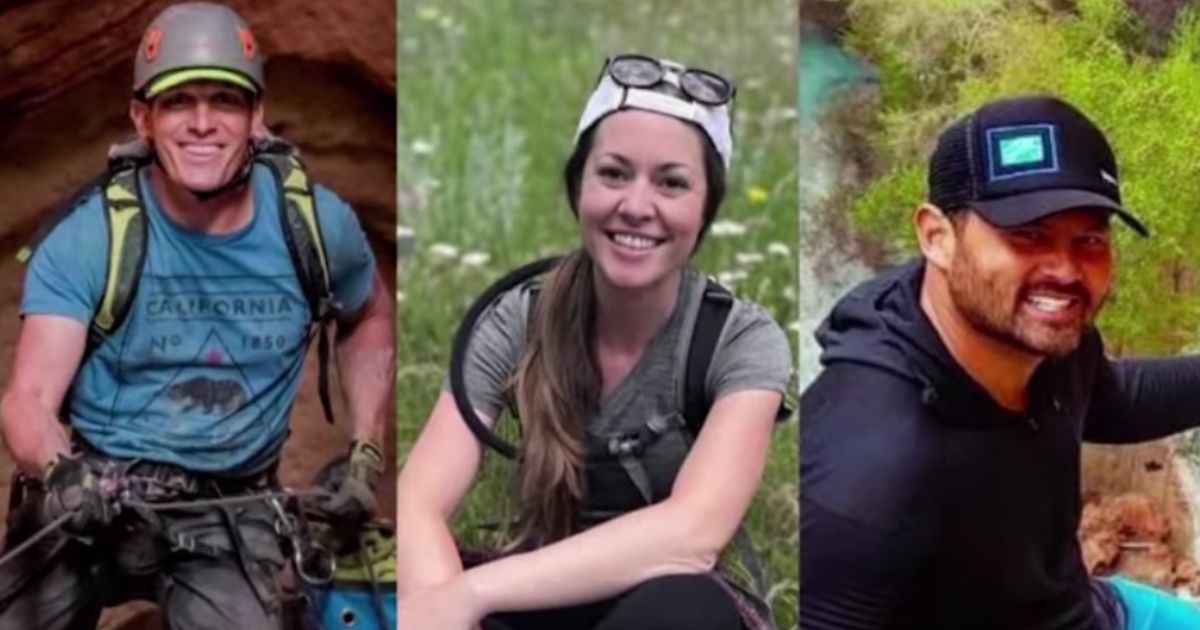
left=89, top=168, right=146, bottom=347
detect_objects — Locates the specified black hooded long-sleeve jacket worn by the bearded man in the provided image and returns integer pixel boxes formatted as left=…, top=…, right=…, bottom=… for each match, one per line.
left=800, top=263, right=1200, bottom=630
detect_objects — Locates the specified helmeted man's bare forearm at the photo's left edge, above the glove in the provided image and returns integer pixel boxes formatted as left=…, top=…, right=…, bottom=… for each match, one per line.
left=0, top=391, right=71, bottom=476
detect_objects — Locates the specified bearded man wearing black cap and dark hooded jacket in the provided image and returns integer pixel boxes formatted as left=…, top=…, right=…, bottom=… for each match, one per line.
left=800, top=96, right=1200, bottom=630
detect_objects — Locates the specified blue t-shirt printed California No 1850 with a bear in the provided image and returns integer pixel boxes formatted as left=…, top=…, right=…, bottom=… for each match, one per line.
left=22, top=164, right=374, bottom=474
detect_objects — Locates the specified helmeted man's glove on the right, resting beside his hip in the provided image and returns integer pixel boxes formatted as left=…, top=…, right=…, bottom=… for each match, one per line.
left=312, top=438, right=383, bottom=524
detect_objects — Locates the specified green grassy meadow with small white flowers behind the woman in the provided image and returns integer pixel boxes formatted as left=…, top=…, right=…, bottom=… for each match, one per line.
left=397, top=0, right=799, bottom=629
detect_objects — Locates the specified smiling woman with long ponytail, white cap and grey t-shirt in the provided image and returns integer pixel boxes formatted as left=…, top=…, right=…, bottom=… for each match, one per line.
left=397, top=50, right=792, bottom=630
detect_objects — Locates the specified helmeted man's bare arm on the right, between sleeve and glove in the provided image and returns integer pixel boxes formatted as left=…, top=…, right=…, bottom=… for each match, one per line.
left=336, top=276, right=396, bottom=446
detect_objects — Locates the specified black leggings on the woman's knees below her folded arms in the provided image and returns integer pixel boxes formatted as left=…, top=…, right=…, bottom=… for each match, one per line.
left=482, top=575, right=743, bottom=630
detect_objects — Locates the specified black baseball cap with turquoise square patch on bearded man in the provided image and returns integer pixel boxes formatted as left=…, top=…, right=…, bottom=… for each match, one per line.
left=929, top=96, right=1150, bottom=236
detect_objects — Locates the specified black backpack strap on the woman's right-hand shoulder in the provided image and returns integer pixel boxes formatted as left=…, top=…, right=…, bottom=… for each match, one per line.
left=683, top=278, right=733, bottom=438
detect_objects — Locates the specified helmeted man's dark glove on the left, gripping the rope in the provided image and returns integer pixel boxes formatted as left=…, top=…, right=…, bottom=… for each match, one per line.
left=42, top=456, right=119, bottom=538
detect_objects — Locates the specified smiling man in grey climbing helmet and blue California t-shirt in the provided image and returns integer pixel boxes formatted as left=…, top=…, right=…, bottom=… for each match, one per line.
left=0, top=2, right=394, bottom=629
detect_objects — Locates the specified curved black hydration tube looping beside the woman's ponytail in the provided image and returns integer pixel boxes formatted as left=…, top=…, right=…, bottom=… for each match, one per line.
left=450, top=257, right=562, bottom=460
